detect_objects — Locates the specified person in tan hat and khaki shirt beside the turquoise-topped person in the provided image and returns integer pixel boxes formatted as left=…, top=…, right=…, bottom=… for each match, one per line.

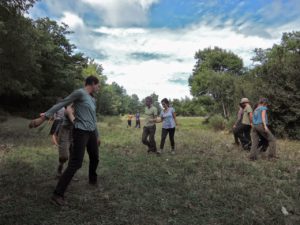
left=237, top=98, right=253, bottom=151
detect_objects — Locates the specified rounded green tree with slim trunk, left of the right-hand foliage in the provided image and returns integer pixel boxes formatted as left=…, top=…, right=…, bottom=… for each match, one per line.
left=189, top=47, right=243, bottom=118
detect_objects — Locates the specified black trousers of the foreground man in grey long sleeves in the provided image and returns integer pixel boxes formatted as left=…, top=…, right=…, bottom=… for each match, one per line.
left=54, top=129, right=99, bottom=197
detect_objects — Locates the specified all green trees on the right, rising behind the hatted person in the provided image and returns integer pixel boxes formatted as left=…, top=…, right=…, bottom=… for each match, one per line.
left=189, top=32, right=300, bottom=139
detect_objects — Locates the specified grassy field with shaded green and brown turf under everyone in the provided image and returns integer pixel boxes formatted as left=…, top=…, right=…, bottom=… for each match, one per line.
left=0, top=118, right=300, bottom=225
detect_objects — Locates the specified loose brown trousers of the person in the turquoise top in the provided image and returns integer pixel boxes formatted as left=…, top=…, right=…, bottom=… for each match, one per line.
left=250, top=124, right=276, bottom=158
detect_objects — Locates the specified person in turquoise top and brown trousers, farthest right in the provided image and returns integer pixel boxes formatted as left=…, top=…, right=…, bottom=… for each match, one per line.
left=250, top=98, right=277, bottom=160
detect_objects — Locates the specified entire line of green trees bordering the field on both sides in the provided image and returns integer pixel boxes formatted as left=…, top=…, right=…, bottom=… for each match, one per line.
left=0, top=0, right=300, bottom=139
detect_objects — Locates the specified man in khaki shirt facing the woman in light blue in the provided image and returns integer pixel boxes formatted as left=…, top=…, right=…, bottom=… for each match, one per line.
left=142, top=96, right=157, bottom=153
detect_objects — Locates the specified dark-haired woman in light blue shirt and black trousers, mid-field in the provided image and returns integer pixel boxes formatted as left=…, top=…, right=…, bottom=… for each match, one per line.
left=155, top=98, right=177, bottom=154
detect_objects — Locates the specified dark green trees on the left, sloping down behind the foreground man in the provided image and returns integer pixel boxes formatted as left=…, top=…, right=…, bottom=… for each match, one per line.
left=0, top=0, right=158, bottom=116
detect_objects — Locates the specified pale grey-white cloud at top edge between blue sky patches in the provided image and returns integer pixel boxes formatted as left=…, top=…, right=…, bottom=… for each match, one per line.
left=82, top=0, right=159, bottom=27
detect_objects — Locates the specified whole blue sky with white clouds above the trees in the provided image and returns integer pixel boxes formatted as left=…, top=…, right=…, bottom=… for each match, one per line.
left=29, top=0, right=300, bottom=99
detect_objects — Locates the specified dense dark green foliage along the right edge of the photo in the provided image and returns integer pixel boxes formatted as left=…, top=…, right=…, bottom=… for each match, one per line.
left=255, top=31, right=300, bottom=139
